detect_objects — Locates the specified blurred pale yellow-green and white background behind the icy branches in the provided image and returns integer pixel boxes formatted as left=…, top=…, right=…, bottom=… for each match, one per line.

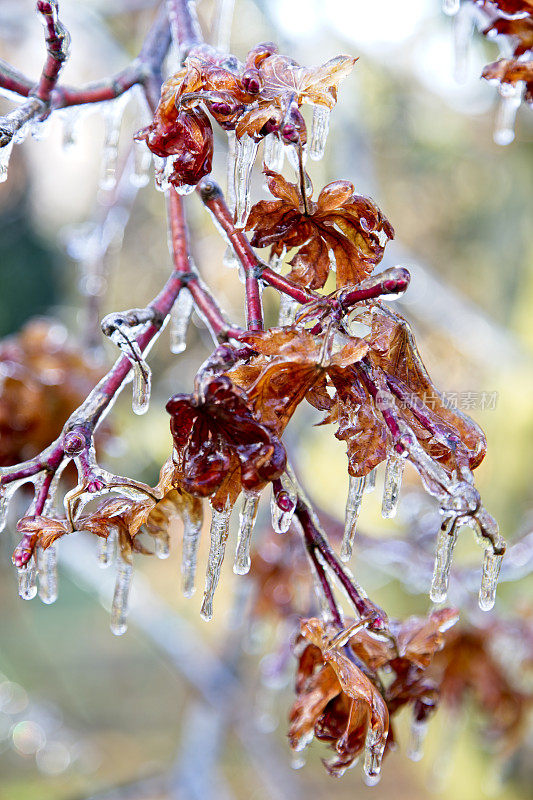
left=0, top=0, right=533, bottom=800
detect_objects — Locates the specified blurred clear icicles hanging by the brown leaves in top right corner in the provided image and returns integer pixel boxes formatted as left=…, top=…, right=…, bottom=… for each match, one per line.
left=442, top=0, right=525, bottom=145
